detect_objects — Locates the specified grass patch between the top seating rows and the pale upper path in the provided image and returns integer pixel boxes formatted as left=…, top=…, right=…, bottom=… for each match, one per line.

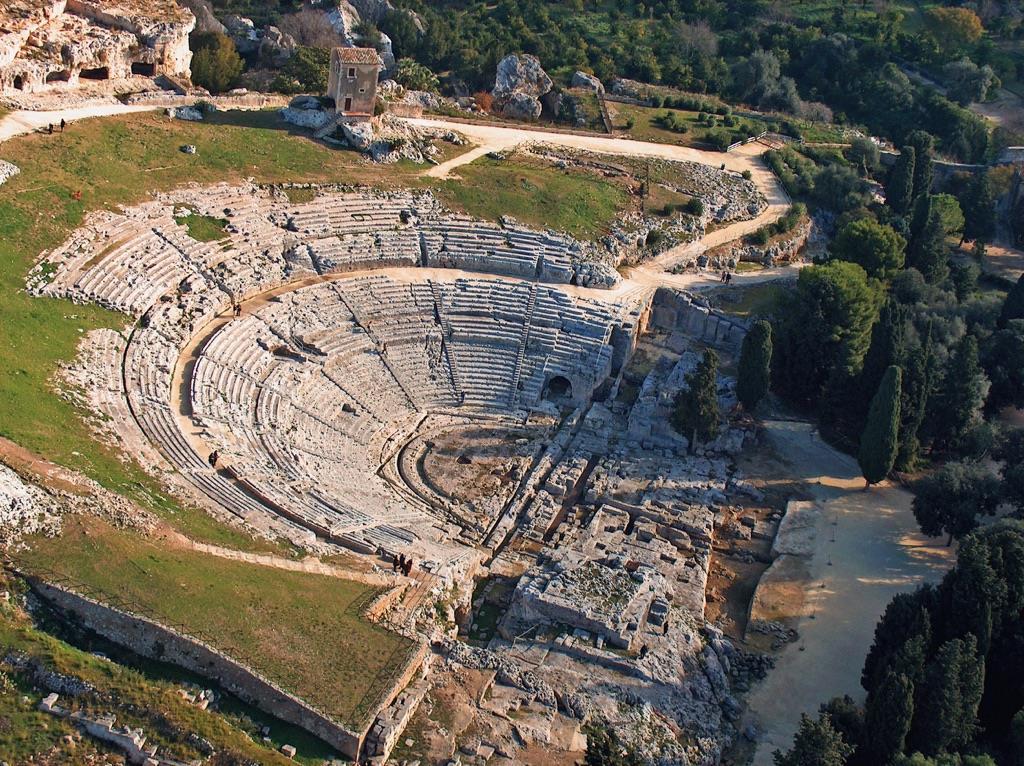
left=436, top=155, right=627, bottom=238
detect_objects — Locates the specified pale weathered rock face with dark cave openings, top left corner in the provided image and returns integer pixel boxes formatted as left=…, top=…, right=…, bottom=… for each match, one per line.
left=0, top=0, right=196, bottom=94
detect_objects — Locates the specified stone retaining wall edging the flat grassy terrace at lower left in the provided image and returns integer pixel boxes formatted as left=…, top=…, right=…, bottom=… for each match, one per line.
left=30, top=579, right=366, bottom=759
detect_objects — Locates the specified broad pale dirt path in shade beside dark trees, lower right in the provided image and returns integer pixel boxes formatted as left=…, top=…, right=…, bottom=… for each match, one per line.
left=744, top=421, right=953, bottom=766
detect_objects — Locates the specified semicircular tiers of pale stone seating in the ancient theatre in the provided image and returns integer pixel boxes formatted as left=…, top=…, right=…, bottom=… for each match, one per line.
left=41, top=186, right=624, bottom=569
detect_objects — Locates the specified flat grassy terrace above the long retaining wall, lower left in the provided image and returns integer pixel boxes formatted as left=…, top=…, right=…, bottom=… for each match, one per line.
left=17, top=518, right=414, bottom=725
